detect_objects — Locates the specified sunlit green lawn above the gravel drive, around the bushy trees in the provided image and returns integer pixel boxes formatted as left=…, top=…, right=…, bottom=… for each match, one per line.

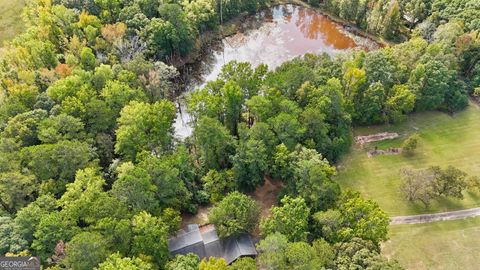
left=336, top=104, right=480, bottom=216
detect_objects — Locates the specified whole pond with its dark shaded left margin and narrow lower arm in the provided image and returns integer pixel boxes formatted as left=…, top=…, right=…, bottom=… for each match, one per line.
left=175, top=2, right=382, bottom=139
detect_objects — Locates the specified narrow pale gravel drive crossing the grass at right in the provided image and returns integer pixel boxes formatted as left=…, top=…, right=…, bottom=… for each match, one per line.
left=390, top=207, right=480, bottom=225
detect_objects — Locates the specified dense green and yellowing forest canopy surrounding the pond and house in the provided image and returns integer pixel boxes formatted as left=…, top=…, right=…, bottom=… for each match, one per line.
left=0, top=0, right=480, bottom=269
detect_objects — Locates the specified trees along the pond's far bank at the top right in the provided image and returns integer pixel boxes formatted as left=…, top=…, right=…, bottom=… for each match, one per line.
left=316, top=0, right=480, bottom=41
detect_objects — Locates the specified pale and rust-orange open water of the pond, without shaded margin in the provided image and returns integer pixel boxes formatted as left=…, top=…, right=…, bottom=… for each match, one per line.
left=175, top=5, right=378, bottom=138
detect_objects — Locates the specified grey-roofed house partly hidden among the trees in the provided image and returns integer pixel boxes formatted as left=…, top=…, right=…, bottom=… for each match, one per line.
left=168, top=224, right=257, bottom=264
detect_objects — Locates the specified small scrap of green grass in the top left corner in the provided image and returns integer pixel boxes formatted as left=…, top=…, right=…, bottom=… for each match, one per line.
left=0, top=0, right=25, bottom=44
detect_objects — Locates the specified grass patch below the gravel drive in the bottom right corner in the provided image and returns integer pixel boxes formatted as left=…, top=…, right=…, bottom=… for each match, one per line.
left=382, top=217, right=480, bottom=270
